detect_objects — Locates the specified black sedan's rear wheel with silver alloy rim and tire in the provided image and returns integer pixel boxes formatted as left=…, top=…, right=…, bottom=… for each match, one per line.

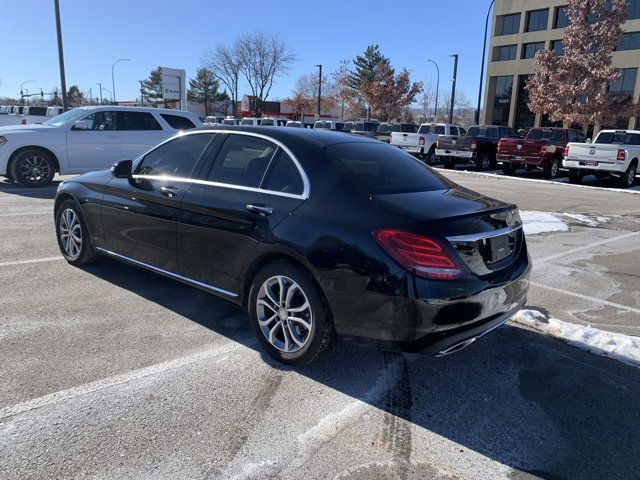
left=248, top=262, right=335, bottom=365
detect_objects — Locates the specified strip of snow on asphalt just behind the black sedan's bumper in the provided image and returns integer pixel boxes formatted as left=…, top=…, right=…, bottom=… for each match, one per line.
left=511, top=310, right=640, bottom=367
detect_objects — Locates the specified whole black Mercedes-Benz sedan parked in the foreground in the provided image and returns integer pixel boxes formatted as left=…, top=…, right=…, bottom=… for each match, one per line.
left=55, top=127, right=530, bottom=365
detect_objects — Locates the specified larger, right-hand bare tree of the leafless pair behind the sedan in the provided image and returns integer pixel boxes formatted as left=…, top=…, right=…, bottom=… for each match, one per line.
left=236, top=32, right=296, bottom=115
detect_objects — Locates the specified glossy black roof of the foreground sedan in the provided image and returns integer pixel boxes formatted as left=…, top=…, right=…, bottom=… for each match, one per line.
left=190, top=125, right=380, bottom=147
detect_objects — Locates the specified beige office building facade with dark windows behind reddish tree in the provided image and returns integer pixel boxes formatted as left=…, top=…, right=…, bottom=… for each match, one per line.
left=484, top=0, right=640, bottom=129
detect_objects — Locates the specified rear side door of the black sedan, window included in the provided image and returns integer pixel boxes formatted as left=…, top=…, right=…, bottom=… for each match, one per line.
left=178, top=132, right=309, bottom=296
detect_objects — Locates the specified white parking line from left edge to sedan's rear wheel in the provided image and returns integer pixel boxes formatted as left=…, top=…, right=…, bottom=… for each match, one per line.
left=0, top=337, right=254, bottom=420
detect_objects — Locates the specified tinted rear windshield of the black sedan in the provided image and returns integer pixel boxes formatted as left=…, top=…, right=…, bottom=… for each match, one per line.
left=326, top=142, right=451, bottom=194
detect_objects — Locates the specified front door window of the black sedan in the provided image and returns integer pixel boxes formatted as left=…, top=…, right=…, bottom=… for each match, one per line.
left=136, top=133, right=214, bottom=178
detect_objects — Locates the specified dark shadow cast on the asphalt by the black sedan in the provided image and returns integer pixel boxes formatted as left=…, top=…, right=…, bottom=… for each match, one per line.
left=85, top=259, right=640, bottom=480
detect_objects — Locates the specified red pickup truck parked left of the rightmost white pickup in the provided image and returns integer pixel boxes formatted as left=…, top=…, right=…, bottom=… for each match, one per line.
left=496, top=128, right=583, bottom=179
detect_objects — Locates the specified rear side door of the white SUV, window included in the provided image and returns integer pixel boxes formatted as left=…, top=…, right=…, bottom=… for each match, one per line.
left=118, top=110, right=170, bottom=159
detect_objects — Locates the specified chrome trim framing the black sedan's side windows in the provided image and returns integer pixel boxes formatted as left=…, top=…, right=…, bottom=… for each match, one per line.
left=132, top=128, right=311, bottom=200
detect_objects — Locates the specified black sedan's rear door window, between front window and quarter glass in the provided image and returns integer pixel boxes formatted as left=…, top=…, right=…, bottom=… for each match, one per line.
left=208, top=134, right=277, bottom=188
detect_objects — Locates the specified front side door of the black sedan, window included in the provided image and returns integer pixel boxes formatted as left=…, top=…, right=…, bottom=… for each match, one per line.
left=102, top=132, right=215, bottom=273
